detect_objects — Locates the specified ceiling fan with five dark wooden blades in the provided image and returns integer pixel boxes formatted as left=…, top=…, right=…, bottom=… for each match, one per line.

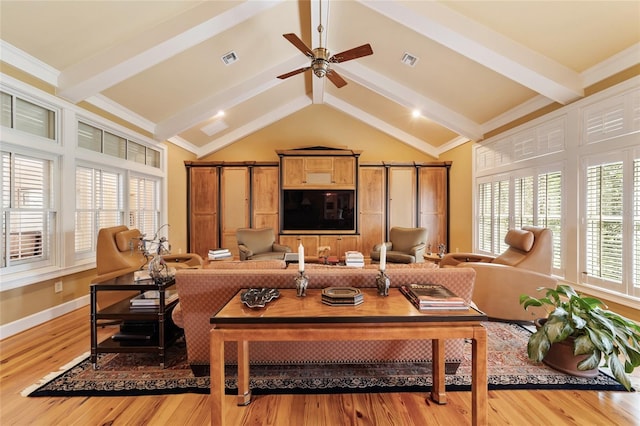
left=278, top=1, right=373, bottom=88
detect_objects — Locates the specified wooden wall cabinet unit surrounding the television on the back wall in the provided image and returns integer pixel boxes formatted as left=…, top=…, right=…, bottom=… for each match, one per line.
left=185, top=147, right=451, bottom=257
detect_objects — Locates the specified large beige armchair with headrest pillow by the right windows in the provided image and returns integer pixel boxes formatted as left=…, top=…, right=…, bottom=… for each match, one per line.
left=440, top=226, right=557, bottom=321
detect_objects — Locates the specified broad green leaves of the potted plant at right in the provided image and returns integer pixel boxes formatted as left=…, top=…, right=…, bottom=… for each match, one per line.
left=520, top=284, right=640, bottom=390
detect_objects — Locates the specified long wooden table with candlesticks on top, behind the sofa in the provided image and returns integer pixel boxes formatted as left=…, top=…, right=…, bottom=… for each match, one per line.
left=210, top=288, right=487, bottom=425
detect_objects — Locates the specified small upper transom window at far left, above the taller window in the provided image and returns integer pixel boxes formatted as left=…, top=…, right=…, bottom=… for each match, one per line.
left=0, top=92, right=56, bottom=140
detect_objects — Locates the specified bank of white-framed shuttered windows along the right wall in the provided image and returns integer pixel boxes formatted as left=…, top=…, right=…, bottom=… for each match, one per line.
left=474, top=79, right=640, bottom=304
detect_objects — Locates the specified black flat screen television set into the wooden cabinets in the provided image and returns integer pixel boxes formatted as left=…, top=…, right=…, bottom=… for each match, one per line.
left=281, top=189, right=356, bottom=233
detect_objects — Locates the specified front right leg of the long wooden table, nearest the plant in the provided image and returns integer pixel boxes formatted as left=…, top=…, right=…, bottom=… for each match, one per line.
left=471, top=326, right=489, bottom=425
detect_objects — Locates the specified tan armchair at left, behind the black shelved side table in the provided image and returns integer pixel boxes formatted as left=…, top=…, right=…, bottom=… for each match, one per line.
left=91, top=225, right=204, bottom=308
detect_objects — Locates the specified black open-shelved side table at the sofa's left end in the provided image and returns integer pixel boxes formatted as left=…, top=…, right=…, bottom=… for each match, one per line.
left=90, top=273, right=178, bottom=369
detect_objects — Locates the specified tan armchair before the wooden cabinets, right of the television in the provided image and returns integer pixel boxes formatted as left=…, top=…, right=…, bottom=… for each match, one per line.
left=371, top=226, right=427, bottom=263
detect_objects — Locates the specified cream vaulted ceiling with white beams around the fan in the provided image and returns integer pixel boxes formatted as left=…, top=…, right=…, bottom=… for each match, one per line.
left=0, top=0, right=640, bottom=157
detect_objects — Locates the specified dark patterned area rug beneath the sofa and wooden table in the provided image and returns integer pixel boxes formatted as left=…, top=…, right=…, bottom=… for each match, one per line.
left=23, top=322, right=624, bottom=397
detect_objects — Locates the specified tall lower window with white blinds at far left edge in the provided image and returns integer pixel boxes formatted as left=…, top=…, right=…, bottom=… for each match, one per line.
left=0, top=151, right=55, bottom=267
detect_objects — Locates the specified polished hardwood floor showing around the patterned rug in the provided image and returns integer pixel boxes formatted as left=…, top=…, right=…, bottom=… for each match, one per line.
left=0, top=308, right=640, bottom=426
